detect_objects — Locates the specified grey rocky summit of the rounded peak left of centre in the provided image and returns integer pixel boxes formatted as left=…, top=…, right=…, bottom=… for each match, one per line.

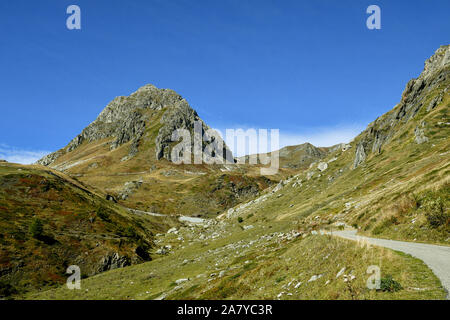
left=38, top=85, right=229, bottom=166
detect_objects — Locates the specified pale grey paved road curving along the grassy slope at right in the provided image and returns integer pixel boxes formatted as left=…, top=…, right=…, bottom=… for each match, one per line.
left=332, top=230, right=450, bottom=299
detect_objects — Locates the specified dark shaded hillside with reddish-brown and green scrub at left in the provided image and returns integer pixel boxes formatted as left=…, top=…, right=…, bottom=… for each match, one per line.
left=0, top=164, right=178, bottom=294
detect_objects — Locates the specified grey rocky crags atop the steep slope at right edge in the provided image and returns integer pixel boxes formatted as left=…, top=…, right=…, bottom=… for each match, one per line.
left=353, top=45, right=450, bottom=168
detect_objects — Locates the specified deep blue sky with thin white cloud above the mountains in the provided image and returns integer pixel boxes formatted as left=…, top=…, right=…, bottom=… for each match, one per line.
left=0, top=0, right=450, bottom=162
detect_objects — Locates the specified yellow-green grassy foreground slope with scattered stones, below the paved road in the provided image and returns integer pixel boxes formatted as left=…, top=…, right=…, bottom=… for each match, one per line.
left=25, top=221, right=446, bottom=299
